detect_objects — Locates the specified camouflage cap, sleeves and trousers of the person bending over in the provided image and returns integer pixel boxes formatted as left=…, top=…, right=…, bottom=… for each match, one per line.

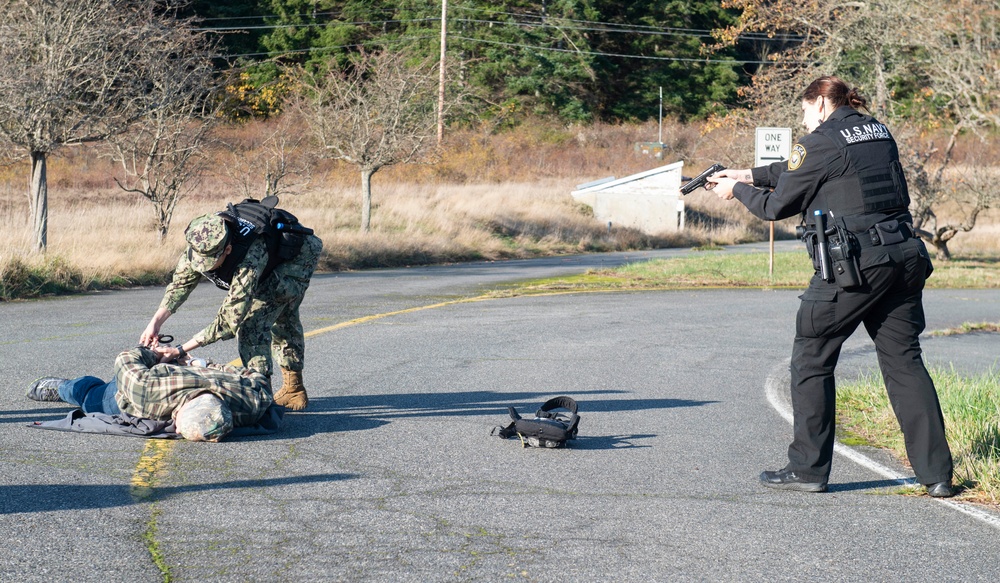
left=160, top=215, right=323, bottom=377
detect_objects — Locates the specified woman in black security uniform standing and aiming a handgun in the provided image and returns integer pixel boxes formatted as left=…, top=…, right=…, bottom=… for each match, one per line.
left=710, top=77, right=953, bottom=497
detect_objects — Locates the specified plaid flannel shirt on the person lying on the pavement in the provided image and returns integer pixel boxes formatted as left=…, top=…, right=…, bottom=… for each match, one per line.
left=115, top=347, right=272, bottom=427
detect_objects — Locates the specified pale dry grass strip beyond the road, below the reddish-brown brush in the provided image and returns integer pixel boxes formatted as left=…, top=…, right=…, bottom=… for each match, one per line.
left=0, top=180, right=742, bottom=280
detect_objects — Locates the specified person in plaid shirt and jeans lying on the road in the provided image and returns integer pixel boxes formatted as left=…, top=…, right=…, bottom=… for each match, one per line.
left=27, top=346, right=273, bottom=441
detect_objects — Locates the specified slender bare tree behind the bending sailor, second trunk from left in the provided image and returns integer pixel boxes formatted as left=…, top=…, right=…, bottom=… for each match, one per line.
left=101, top=20, right=221, bottom=243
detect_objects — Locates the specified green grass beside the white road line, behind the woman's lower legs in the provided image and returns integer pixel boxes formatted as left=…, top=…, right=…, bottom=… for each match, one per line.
left=837, top=368, right=1000, bottom=504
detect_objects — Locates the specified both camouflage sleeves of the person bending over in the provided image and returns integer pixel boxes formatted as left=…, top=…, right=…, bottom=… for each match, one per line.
left=160, top=237, right=268, bottom=346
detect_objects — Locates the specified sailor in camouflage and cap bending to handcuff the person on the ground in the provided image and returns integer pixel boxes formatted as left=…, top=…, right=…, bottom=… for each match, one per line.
left=140, top=208, right=323, bottom=411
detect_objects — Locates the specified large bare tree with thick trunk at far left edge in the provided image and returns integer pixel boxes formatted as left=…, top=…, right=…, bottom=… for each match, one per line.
left=0, top=0, right=204, bottom=251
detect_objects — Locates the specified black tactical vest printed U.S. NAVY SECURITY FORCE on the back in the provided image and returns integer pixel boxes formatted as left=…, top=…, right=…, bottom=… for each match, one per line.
left=807, top=114, right=910, bottom=231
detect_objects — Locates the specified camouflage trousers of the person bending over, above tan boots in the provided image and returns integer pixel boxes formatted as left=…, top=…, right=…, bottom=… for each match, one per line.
left=236, top=235, right=323, bottom=377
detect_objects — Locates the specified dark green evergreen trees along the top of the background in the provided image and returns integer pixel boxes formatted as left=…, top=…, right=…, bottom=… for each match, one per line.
left=188, top=0, right=741, bottom=121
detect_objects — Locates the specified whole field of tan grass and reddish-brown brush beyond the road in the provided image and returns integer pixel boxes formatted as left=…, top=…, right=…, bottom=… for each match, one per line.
left=0, top=123, right=1000, bottom=298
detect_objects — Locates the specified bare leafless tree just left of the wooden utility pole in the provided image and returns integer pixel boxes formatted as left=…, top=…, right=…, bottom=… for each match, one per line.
left=293, top=51, right=447, bottom=232
